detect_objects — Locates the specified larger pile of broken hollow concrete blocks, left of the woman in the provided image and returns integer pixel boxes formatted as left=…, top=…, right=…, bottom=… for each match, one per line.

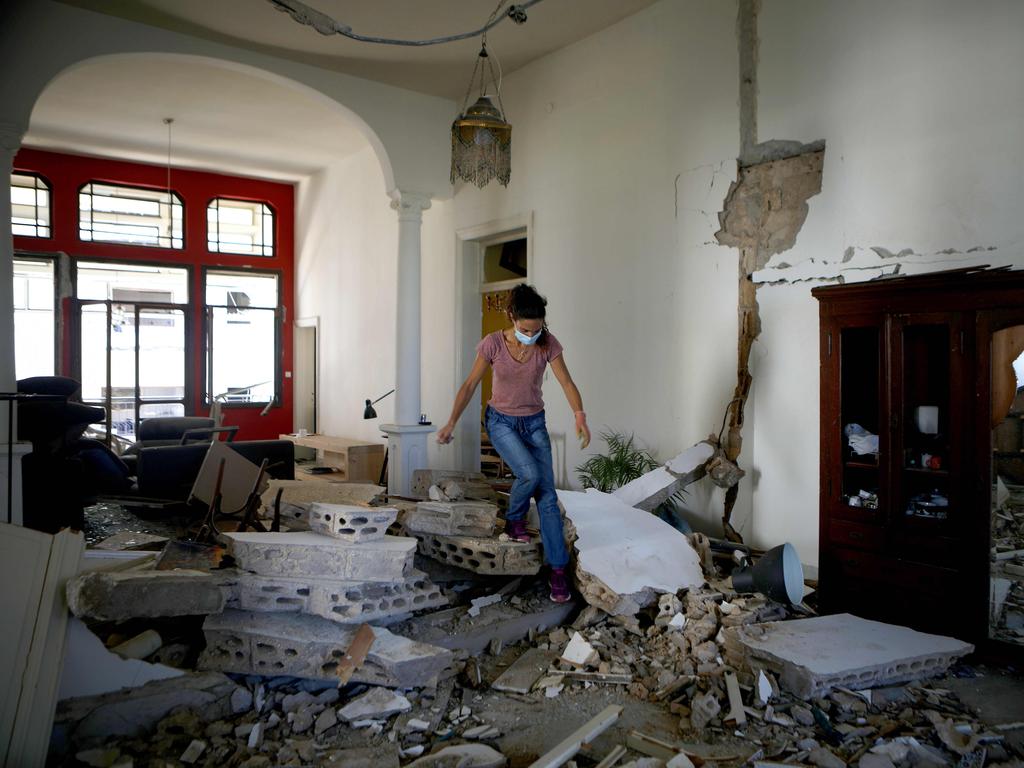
left=201, top=504, right=451, bottom=685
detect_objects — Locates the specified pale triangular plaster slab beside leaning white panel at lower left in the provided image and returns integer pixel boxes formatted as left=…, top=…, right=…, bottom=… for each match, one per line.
left=57, top=616, right=184, bottom=699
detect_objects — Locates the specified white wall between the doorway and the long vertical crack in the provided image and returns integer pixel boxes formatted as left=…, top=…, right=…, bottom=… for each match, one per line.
left=444, top=1, right=738, bottom=532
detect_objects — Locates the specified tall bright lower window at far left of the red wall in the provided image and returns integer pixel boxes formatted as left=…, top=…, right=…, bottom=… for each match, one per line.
left=13, top=257, right=56, bottom=379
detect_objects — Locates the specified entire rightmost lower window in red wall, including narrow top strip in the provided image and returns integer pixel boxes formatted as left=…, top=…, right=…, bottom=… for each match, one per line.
left=206, top=270, right=280, bottom=402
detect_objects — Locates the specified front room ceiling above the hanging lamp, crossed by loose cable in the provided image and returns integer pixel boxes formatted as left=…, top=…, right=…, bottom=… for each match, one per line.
left=61, top=0, right=655, bottom=100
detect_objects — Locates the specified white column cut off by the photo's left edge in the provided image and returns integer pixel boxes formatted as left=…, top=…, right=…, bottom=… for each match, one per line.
left=0, top=123, right=30, bottom=523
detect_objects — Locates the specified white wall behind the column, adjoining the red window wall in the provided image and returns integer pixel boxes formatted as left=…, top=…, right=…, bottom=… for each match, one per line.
left=295, top=145, right=454, bottom=462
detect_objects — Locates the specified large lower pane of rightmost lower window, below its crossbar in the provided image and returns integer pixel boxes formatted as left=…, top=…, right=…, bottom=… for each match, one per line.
left=208, top=307, right=276, bottom=402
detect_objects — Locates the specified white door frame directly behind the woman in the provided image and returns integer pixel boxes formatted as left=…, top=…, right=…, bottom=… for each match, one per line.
left=453, top=211, right=536, bottom=472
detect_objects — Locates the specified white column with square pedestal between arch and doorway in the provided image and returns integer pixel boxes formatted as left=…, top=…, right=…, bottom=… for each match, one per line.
left=381, top=189, right=434, bottom=496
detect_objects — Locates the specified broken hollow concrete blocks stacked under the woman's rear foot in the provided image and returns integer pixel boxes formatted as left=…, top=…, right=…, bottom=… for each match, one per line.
left=401, top=502, right=543, bottom=575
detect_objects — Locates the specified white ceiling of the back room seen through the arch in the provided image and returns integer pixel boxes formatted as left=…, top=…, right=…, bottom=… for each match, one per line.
left=25, top=56, right=369, bottom=180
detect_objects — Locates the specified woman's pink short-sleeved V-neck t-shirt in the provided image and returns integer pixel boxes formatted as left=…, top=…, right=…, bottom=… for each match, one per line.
left=476, top=331, right=562, bottom=416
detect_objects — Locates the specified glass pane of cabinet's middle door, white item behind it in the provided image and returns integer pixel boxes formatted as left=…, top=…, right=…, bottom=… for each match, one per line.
left=900, top=325, right=950, bottom=521
